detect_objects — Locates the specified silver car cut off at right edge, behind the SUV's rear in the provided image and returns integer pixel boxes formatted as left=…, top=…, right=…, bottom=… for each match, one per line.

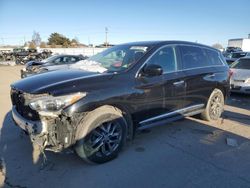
left=230, top=57, right=250, bottom=94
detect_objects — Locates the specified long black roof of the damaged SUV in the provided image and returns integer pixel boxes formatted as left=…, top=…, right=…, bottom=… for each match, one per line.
left=118, top=40, right=219, bottom=51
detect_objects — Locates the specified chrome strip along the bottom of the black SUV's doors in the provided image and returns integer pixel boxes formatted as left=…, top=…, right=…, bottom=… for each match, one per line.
left=139, top=104, right=205, bottom=124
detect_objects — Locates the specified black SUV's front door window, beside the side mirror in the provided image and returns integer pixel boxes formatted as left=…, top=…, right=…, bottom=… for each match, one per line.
left=147, top=47, right=177, bottom=73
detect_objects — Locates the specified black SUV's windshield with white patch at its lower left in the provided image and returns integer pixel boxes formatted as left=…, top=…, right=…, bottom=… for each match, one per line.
left=73, top=45, right=149, bottom=72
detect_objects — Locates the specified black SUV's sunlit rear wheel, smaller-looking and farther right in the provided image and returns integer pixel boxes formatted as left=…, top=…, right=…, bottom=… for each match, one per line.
left=201, top=89, right=225, bottom=121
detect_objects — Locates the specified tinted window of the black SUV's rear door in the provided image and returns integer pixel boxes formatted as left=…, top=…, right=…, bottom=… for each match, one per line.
left=180, top=46, right=209, bottom=69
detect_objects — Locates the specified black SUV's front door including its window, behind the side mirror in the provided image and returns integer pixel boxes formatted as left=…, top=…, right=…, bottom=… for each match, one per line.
left=137, top=46, right=185, bottom=124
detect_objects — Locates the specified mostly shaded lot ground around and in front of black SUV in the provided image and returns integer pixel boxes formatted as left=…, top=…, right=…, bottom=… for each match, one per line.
left=0, top=66, right=250, bottom=188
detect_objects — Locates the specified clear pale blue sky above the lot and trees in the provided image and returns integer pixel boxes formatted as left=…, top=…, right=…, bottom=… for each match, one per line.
left=0, top=0, right=250, bottom=47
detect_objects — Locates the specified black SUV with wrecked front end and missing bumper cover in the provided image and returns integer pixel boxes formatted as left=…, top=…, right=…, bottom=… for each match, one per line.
left=11, top=41, right=229, bottom=163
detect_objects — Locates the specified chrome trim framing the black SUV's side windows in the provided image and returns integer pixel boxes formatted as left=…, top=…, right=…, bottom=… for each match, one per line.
left=135, top=44, right=226, bottom=78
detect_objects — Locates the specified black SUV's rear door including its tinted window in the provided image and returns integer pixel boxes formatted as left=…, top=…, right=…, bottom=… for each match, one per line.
left=178, top=45, right=222, bottom=108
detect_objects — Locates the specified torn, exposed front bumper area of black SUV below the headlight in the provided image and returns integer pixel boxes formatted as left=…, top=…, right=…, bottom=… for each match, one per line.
left=12, top=106, right=75, bottom=152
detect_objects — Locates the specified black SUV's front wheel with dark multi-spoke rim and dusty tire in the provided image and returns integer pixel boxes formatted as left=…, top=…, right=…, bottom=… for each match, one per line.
left=75, top=106, right=127, bottom=163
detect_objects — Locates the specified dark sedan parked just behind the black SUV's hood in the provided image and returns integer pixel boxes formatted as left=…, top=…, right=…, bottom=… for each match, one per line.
left=21, top=55, right=87, bottom=78
